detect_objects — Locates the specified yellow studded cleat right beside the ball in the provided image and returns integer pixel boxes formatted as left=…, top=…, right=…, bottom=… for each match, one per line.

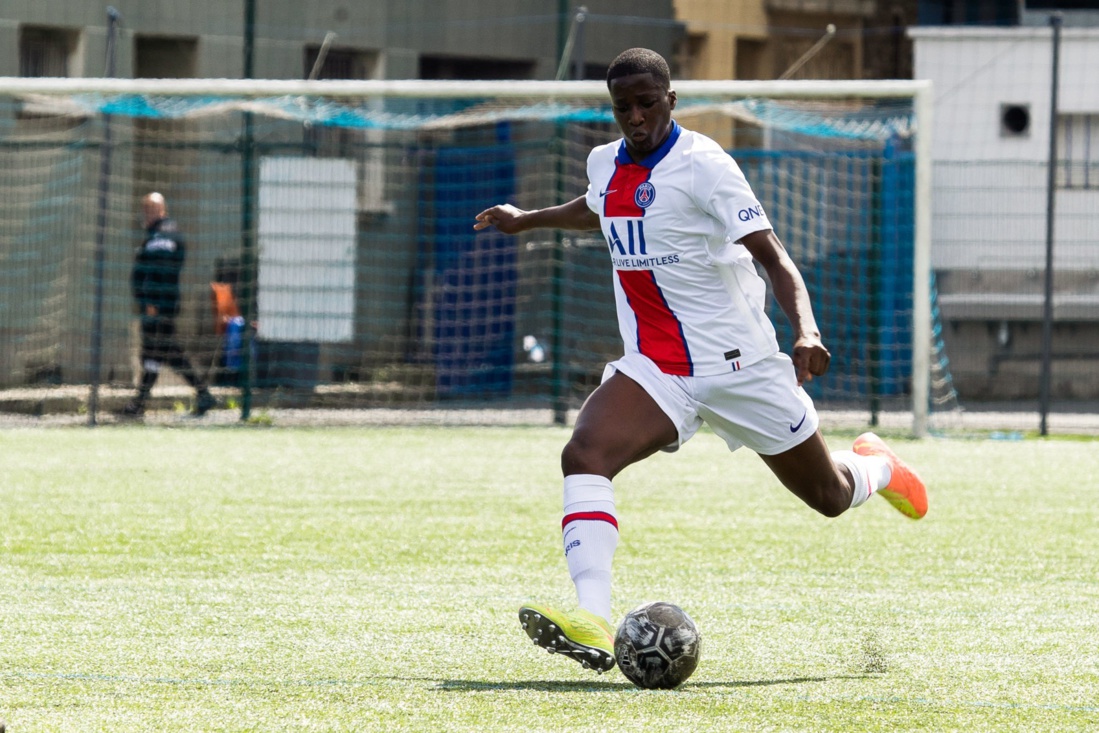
left=519, top=603, right=614, bottom=675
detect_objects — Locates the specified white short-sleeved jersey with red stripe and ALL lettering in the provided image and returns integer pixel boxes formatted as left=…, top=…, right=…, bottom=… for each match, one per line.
left=587, top=122, right=778, bottom=377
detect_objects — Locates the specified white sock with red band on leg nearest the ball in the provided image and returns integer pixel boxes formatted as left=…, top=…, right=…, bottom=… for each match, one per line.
left=560, top=474, right=618, bottom=621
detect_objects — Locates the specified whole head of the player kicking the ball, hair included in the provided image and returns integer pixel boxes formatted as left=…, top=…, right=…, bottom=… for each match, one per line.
left=607, top=48, right=676, bottom=160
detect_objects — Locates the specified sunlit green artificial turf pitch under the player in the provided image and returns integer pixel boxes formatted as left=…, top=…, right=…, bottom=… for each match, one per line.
left=0, top=426, right=1099, bottom=733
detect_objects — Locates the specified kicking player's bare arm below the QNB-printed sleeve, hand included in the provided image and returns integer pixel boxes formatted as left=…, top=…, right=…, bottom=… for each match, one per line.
left=741, top=229, right=832, bottom=385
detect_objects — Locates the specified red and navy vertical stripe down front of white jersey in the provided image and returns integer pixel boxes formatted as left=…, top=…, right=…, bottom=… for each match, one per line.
left=603, top=122, right=693, bottom=377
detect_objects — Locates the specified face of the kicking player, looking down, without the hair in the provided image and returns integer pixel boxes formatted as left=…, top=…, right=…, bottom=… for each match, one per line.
left=610, top=74, right=676, bottom=162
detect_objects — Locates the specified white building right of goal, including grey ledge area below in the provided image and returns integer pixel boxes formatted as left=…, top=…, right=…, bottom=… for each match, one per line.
left=911, top=25, right=1099, bottom=400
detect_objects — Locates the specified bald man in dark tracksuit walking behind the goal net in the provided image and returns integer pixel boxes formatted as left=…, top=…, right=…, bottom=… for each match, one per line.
left=122, top=191, right=218, bottom=418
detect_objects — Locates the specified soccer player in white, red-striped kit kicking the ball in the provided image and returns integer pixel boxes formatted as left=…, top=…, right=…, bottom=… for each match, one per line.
left=474, top=48, right=928, bottom=671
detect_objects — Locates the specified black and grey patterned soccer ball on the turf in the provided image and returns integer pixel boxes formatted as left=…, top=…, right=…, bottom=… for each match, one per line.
left=614, top=601, right=702, bottom=690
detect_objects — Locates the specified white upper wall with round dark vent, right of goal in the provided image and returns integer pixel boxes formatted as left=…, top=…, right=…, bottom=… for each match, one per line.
left=910, top=26, right=1099, bottom=271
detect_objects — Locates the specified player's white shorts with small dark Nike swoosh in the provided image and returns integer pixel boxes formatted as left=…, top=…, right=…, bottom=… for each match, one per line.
left=602, top=353, right=820, bottom=456
